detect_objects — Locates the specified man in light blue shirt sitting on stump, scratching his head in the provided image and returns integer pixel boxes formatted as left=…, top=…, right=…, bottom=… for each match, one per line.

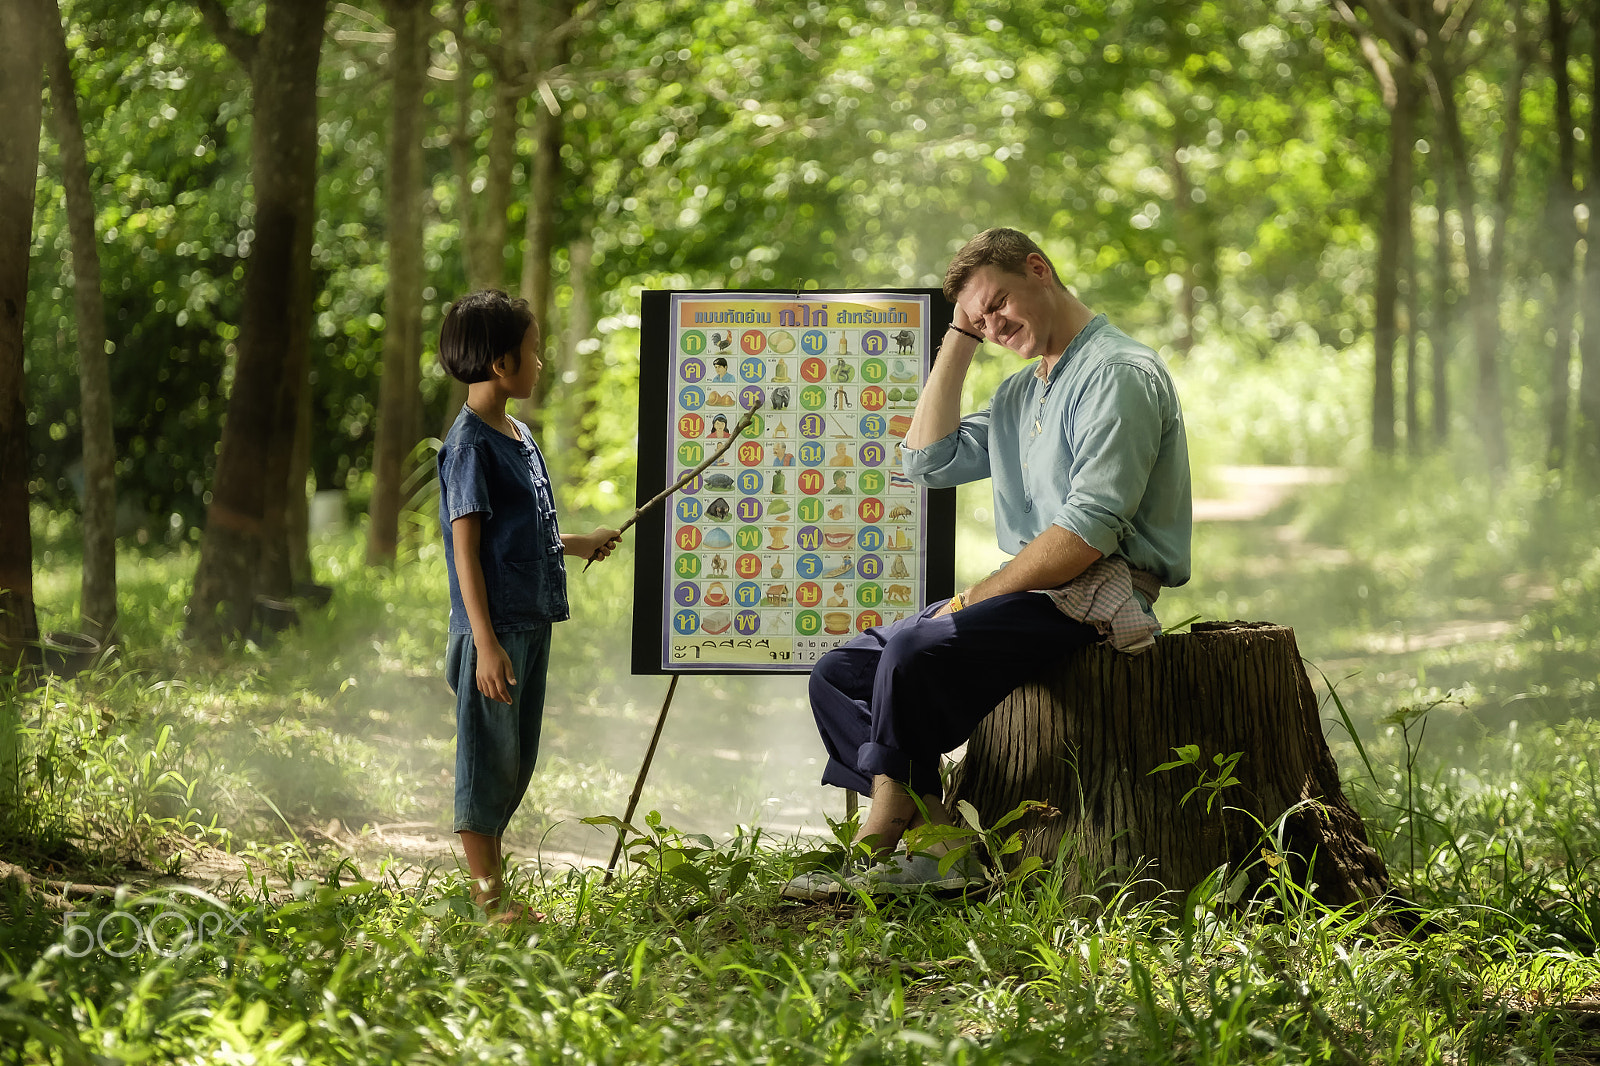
left=782, top=229, right=1192, bottom=900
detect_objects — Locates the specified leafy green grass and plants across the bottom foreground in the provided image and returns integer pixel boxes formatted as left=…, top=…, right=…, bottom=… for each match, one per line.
left=9, top=777, right=1600, bottom=1063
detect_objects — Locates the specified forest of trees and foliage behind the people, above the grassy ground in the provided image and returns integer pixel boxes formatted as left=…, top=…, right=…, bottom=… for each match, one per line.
left=3, top=0, right=1600, bottom=648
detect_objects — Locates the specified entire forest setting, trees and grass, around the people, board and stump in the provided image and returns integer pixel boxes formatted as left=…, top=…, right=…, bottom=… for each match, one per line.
left=0, top=0, right=1600, bottom=1063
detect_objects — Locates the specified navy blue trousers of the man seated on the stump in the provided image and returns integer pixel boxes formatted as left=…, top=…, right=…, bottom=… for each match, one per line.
left=811, top=592, right=1101, bottom=795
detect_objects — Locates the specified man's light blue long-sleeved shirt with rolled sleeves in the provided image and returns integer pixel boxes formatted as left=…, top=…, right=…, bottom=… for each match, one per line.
left=904, top=315, right=1194, bottom=586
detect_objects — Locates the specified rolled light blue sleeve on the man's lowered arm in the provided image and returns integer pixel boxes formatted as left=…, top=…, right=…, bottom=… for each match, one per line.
left=1051, top=363, right=1170, bottom=555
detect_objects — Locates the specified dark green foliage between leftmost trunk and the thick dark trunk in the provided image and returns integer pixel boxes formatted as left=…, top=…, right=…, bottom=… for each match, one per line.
left=27, top=2, right=250, bottom=522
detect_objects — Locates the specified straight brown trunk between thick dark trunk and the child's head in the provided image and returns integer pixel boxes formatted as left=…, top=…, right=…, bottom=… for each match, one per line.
left=366, top=0, right=427, bottom=565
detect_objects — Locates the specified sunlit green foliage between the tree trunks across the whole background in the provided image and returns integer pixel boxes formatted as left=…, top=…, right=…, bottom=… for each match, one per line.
left=29, top=0, right=1581, bottom=538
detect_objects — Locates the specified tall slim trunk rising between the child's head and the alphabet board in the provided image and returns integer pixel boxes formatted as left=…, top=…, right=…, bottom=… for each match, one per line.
left=522, top=0, right=576, bottom=434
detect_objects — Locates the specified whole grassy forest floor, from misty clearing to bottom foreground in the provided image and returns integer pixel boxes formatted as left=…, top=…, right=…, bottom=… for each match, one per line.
left=0, top=461, right=1600, bottom=1064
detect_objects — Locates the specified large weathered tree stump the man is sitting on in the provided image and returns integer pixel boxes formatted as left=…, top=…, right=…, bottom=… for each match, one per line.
left=950, top=621, right=1389, bottom=906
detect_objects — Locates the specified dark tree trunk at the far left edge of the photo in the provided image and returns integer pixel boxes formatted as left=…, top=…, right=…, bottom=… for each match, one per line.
left=0, top=0, right=51, bottom=672
